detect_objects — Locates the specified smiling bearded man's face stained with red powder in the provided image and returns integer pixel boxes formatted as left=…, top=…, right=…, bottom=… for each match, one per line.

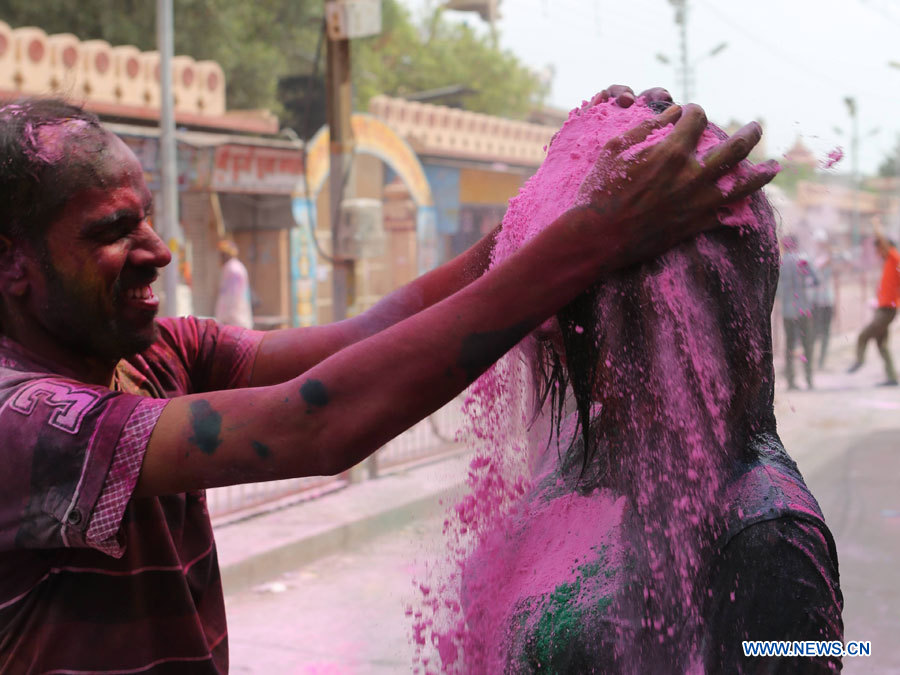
left=29, top=132, right=171, bottom=361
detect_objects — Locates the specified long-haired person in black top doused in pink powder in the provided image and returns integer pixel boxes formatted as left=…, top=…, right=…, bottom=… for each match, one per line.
left=460, top=91, right=843, bottom=673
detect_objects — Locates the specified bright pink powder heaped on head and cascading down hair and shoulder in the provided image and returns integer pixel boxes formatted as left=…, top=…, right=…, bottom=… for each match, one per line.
left=410, top=97, right=777, bottom=673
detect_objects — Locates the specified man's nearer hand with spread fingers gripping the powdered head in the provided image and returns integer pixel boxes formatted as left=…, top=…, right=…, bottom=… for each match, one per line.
left=578, top=101, right=779, bottom=264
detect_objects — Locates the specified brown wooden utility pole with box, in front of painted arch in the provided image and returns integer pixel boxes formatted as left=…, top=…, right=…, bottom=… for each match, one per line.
left=325, top=0, right=355, bottom=321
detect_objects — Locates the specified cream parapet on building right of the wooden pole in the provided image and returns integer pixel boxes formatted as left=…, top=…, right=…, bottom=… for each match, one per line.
left=369, top=96, right=557, bottom=167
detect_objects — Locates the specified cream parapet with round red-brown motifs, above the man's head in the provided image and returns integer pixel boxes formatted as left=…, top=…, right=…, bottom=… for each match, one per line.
left=0, top=21, right=236, bottom=121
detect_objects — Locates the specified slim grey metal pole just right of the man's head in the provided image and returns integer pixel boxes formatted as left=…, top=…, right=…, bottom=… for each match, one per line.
left=156, top=0, right=179, bottom=316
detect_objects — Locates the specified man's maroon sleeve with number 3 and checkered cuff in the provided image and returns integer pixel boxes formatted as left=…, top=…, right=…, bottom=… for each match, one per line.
left=0, top=377, right=166, bottom=556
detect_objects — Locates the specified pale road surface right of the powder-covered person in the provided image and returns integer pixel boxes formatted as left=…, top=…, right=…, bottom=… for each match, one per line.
left=776, top=331, right=900, bottom=674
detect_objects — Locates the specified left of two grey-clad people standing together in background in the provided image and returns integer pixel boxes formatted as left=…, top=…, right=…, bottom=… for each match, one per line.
left=778, top=235, right=816, bottom=389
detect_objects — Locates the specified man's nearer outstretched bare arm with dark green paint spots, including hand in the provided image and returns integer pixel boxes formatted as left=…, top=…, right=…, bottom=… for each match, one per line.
left=136, top=106, right=775, bottom=495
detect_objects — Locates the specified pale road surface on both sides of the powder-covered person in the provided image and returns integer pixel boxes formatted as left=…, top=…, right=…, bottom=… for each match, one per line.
left=226, top=337, right=900, bottom=675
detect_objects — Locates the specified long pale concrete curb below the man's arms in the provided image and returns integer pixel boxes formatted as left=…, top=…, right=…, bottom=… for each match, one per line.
left=215, top=455, right=469, bottom=594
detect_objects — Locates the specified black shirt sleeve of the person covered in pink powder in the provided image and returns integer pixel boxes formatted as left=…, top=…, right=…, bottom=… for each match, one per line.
left=706, top=517, right=844, bottom=673
